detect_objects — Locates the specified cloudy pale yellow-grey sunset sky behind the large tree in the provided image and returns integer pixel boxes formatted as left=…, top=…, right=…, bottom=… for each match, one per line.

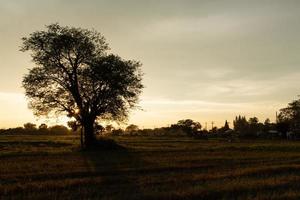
left=0, top=0, right=300, bottom=128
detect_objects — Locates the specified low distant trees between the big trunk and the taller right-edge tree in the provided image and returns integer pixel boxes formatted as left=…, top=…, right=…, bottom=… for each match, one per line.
left=103, top=116, right=277, bottom=138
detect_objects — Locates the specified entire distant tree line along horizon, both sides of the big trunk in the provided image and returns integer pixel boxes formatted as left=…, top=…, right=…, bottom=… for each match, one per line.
left=0, top=99, right=300, bottom=139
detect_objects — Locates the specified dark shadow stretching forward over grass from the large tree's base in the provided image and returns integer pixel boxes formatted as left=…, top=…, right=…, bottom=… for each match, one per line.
left=80, top=140, right=146, bottom=199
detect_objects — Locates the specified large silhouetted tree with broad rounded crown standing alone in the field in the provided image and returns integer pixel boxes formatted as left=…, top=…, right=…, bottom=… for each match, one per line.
left=21, top=24, right=143, bottom=147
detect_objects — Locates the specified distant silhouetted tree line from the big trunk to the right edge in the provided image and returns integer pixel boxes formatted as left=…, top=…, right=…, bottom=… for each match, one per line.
left=104, top=99, right=300, bottom=139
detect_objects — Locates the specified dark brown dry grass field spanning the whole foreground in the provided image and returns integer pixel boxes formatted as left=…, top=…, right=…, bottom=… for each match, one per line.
left=0, top=136, right=300, bottom=200
